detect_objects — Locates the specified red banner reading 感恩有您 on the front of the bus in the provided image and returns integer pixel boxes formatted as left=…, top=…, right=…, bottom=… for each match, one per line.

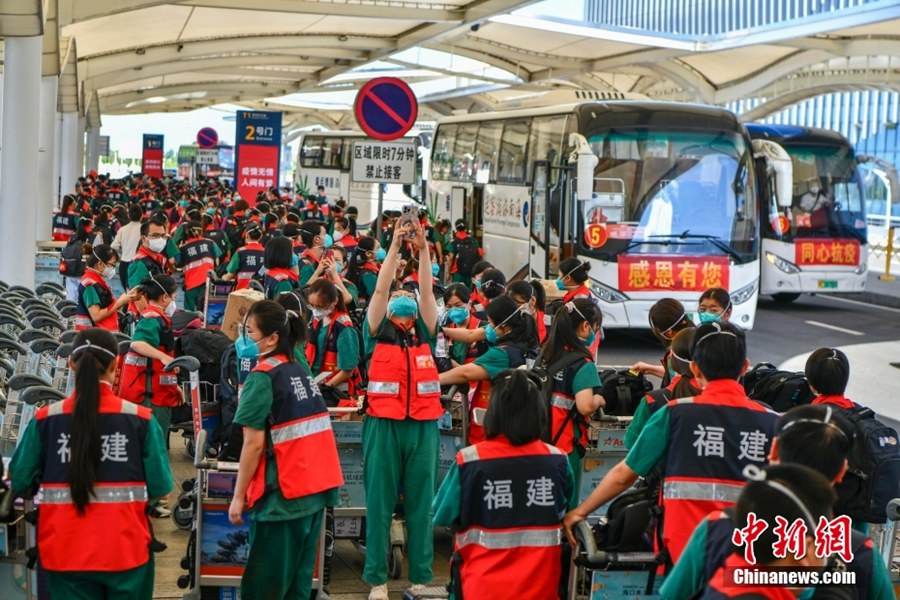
left=619, top=254, right=729, bottom=292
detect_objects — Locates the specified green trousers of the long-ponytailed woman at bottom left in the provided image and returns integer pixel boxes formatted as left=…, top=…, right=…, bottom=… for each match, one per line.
left=47, top=552, right=154, bottom=600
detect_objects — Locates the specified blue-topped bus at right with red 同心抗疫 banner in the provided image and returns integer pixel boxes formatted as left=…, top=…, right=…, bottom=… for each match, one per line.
left=747, top=123, right=888, bottom=302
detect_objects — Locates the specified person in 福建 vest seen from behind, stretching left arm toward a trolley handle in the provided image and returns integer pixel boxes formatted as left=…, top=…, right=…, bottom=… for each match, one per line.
left=565, top=323, right=778, bottom=563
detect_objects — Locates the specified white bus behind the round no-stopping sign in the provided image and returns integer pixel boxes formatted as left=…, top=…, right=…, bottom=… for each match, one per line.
left=294, top=127, right=432, bottom=224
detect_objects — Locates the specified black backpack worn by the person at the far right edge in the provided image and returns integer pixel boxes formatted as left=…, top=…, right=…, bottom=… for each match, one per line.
left=835, top=406, right=900, bottom=523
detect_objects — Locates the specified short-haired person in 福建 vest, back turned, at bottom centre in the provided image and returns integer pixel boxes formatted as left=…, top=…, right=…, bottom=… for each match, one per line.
left=434, top=370, right=575, bottom=600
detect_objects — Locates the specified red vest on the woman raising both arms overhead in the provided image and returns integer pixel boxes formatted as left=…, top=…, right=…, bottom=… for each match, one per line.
left=366, top=320, right=444, bottom=421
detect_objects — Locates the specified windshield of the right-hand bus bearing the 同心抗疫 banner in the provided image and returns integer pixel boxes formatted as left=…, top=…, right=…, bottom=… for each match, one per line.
left=784, top=145, right=866, bottom=241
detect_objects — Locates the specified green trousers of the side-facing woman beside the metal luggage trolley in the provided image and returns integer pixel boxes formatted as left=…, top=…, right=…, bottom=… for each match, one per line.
left=241, top=510, right=324, bottom=600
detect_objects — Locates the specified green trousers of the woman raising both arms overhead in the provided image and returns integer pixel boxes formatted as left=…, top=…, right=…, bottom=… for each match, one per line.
left=363, top=416, right=441, bottom=586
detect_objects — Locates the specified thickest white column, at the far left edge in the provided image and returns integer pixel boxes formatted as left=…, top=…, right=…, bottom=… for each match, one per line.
left=0, top=36, right=42, bottom=286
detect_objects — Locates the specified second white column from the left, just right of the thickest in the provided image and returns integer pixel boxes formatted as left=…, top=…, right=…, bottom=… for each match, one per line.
left=35, top=76, right=59, bottom=241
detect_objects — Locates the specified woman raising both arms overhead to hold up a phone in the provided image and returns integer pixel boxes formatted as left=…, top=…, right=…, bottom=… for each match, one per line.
left=363, top=221, right=444, bottom=600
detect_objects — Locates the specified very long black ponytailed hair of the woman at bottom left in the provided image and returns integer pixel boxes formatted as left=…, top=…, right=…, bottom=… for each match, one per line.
left=66, top=327, right=118, bottom=515
